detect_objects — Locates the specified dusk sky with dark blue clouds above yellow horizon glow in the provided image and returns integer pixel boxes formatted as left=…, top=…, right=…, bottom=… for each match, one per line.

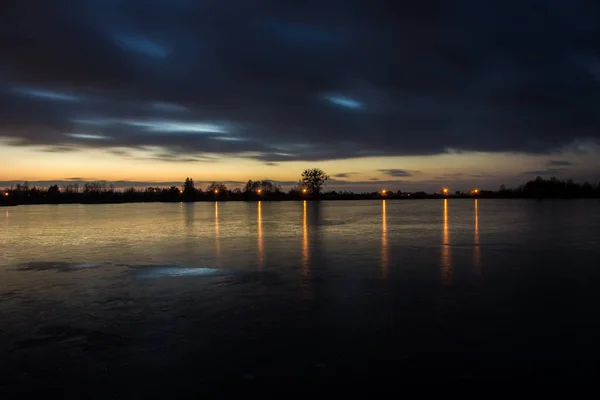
left=0, top=0, right=600, bottom=191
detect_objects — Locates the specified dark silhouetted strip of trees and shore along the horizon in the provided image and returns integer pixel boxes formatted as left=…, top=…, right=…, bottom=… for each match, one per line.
left=0, top=168, right=600, bottom=206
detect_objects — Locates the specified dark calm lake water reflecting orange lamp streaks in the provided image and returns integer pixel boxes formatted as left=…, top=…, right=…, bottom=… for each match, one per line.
left=0, top=199, right=600, bottom=398
